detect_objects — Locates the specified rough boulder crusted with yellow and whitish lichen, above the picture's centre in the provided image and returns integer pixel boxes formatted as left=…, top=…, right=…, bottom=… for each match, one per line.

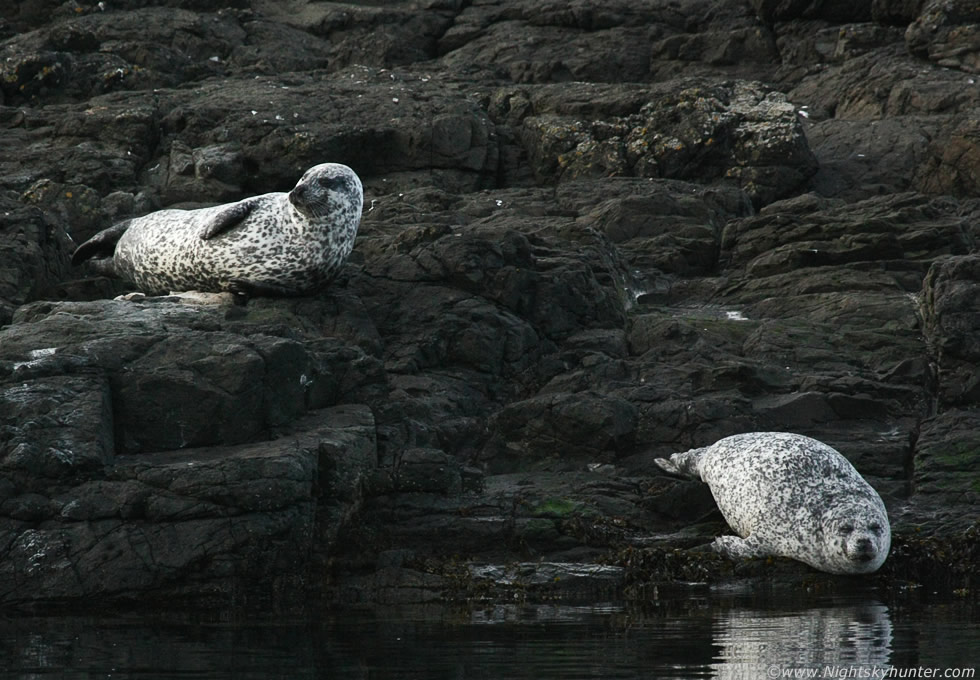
left=522, top=82, right=816, bottom=204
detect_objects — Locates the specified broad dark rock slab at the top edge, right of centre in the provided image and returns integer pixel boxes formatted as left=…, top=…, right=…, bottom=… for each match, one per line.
left=440, top=0, right=774, bottom=83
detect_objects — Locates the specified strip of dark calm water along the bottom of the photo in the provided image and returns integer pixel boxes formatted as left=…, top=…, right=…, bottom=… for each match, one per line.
left=0, top=595, right=980, bottom=680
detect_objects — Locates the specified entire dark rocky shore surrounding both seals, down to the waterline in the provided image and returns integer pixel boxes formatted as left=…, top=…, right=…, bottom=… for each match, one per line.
left=0, top=0, right=980, bottom=606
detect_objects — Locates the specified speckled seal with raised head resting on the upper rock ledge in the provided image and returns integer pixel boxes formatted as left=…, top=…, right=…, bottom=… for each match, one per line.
left=71, top=163, right=364, bottom=297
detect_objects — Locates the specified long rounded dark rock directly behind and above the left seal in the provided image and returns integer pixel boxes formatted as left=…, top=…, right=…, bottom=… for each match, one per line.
left=152, top=67, right=497, bottom=201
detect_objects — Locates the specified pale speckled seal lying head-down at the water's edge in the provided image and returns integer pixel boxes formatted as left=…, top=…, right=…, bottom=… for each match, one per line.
left=655, top=432, right=891, bottom=574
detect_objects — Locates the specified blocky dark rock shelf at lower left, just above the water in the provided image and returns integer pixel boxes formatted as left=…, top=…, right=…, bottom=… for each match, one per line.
left=0, top=408, right=376, bottom=606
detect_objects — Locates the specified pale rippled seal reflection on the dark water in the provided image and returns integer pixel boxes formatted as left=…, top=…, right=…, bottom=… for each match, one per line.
left=712, top=602, right=892, bottom=678
